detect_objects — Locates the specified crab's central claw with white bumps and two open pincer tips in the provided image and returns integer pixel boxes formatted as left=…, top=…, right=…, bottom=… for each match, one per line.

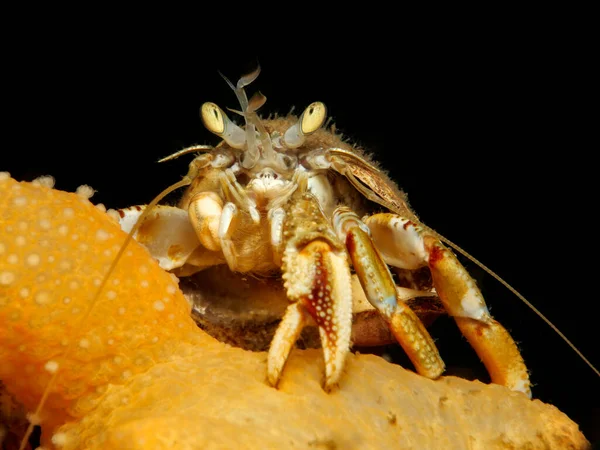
left=267, top=194, right=352, bottom=390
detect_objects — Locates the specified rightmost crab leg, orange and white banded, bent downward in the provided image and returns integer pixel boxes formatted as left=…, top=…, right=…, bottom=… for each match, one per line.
left=365, top=214, right=531, bottom=397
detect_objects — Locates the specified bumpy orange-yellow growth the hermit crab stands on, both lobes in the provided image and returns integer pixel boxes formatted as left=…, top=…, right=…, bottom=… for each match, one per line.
left=0, top=174, right=589, bottom=449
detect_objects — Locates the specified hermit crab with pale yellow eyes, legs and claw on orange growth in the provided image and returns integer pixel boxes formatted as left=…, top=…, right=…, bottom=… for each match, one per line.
left=119, top=69, right=531, bottom=396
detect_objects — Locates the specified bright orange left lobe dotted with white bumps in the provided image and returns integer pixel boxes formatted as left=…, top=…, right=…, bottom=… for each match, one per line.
left=0, top=178, right=212, bottom=442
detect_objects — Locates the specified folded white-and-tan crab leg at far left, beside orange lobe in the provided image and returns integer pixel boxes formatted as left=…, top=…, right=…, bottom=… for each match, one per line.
left=117, top=205, right=200, bottom=270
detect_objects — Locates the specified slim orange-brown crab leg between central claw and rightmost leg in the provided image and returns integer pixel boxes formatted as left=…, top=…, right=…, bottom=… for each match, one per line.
left=333, top=207, right=444, bottom=378
